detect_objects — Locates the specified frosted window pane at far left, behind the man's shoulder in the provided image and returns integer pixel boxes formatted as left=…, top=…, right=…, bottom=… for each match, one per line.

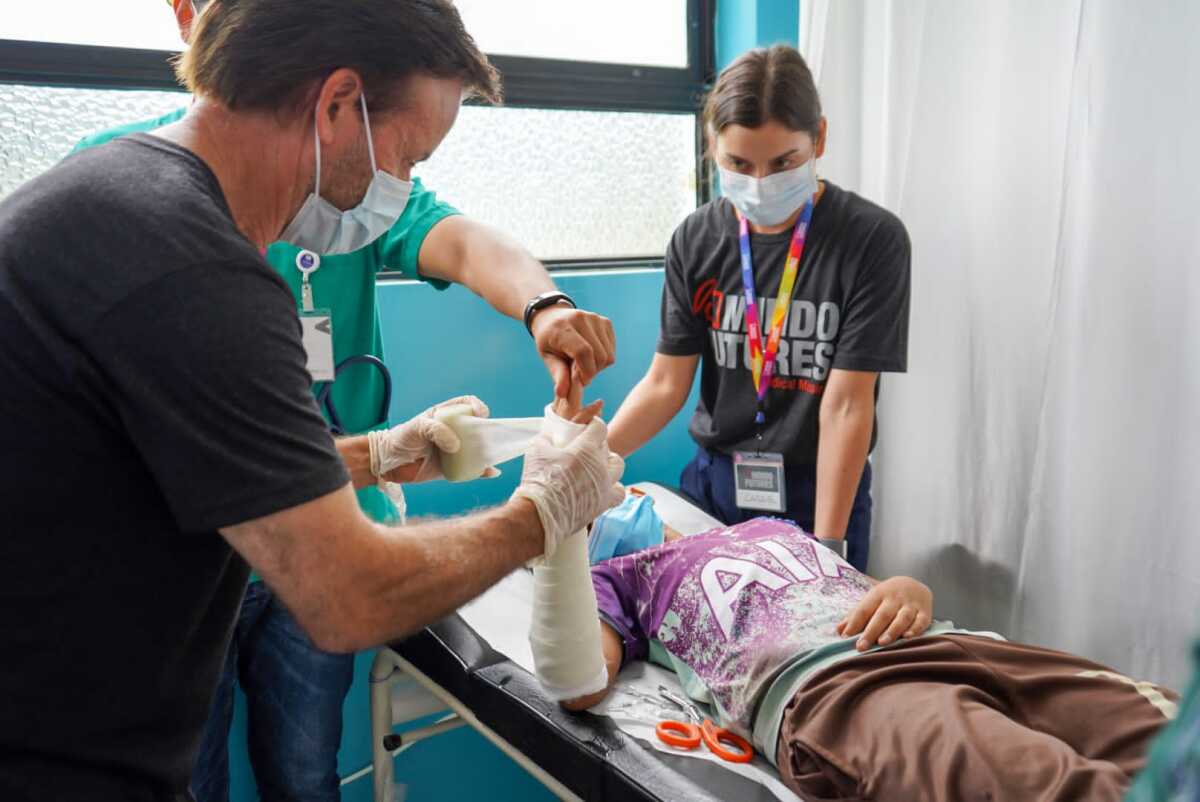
left=0, top=84, right=188, bottom=197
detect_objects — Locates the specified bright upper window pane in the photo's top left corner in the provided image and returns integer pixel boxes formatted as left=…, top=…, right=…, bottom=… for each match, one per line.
left=0, top=0, right=184, bottom=50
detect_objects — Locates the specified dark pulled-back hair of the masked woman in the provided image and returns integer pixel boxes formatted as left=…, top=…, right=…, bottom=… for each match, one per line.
left=703, top=44, right=821, bottom=139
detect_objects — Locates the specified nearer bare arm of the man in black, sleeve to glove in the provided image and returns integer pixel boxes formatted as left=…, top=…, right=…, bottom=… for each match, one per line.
left=221, top=485, right=545, bottom=652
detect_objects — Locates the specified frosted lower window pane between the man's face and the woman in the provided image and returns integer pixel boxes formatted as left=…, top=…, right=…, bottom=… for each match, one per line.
left=414, top=106, right=696, bottom=259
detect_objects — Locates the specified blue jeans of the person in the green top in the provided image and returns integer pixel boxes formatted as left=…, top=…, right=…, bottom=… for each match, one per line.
left=192, top=582, right=354, bottom=802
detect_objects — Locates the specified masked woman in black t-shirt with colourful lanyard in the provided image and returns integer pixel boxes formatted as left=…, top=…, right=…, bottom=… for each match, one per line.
left=608, top=46, right=910, bottom=570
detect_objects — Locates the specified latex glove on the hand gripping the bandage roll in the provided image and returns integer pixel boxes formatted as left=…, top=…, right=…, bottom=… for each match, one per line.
left=367, top=395, right=498, bottom=483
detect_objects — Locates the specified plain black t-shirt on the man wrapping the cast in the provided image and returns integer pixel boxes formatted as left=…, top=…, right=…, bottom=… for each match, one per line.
left=0, top=134, right=348, bottom=802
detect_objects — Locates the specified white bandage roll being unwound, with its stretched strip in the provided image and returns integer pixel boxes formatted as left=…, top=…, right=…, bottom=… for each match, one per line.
left=433, top=403, right=542, bottom=481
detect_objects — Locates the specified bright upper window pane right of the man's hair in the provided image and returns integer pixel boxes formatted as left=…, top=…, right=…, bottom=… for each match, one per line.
left=455, top=0, right=688, bottom=67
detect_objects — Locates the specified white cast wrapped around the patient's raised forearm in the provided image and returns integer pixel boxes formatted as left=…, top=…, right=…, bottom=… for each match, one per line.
left=529, top=407, right=608, bottom=701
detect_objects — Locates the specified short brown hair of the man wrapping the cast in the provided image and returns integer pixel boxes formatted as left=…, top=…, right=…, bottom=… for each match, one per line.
left=175, top=0, right=500, bottom=115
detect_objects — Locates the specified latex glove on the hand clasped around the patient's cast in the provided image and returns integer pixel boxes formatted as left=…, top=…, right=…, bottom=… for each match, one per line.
left=512, top=418, right=625, bottom=557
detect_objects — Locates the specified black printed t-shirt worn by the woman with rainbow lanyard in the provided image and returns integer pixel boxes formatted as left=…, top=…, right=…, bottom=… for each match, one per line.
left=658, top=181, right=911, bottom=466
